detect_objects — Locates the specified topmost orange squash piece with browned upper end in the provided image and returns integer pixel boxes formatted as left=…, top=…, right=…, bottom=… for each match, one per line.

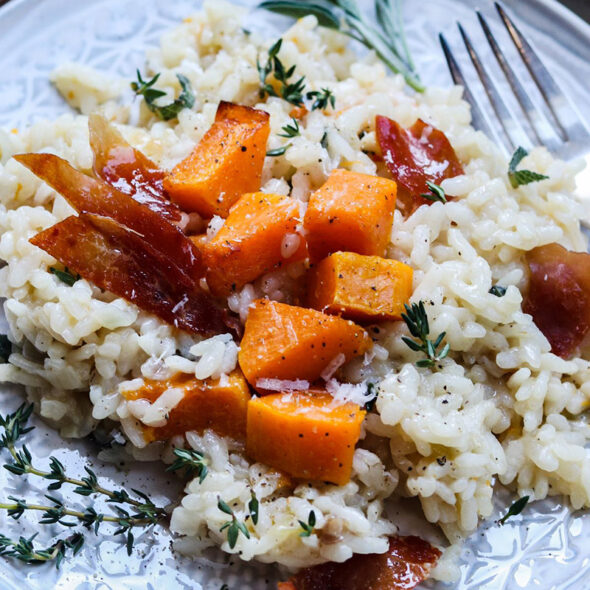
left=164, top=102, right=270, bottom=217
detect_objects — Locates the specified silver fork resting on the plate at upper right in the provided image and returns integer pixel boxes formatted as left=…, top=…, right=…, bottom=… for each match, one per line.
left=439, top=2, right=590, bottom=217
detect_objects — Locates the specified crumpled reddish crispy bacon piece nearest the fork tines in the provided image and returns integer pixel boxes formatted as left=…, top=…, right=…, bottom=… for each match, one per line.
left=376, top=115, right=463, bottom=215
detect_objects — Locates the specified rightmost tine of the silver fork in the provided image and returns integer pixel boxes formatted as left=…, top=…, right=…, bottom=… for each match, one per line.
left=494, top=2, right=590, bottom=141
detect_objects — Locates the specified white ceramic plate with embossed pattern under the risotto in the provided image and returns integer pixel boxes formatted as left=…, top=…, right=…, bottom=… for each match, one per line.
left=0, top=0, right=590, bottom=590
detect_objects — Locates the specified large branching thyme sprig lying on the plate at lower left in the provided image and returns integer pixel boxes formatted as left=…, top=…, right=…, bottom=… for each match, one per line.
left=0, top=404, right=167, bottom=565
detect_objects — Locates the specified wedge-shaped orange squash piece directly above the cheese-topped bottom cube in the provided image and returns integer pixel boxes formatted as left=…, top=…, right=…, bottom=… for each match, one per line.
left=238, top=299, right=372, bottom=387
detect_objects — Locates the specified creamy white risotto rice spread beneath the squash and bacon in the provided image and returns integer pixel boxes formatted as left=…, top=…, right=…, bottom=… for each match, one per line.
left=0, top=0, right=590, bottom=581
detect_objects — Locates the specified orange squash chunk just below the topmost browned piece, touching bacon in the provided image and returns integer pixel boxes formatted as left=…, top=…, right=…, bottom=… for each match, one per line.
left=202, top=193, right=307, bottom=296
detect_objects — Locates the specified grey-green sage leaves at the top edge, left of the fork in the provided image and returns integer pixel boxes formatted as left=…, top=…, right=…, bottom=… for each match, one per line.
left=259, top=0, right=424, bottom=92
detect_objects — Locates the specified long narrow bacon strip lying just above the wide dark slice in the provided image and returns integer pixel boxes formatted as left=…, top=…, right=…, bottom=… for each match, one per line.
left=14, top=154, right=204, bottom=282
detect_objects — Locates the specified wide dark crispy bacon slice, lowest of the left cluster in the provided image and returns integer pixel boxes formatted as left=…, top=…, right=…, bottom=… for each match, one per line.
left=30, top=213, right=226, bottom=335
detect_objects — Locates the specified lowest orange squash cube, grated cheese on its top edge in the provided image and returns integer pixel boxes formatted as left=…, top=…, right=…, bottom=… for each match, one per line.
left=246, top=392, right=366, bottom=485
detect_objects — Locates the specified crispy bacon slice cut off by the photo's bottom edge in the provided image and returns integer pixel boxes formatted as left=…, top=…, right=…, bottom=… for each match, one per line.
left=278, top=536, right=441, bottom=590
